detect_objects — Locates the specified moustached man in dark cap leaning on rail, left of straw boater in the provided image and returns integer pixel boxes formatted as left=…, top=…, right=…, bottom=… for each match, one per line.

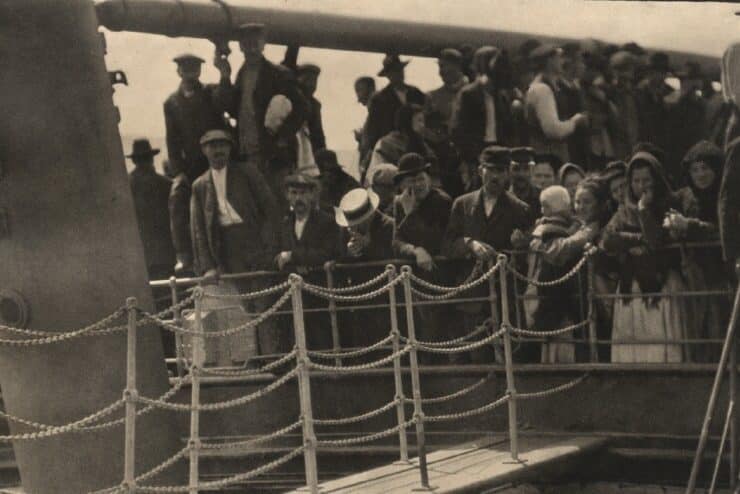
left=275, top=173, right=339, bottom=351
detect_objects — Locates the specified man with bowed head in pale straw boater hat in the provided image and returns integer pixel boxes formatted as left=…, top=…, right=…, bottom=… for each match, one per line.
left=335, top=188, right=393, bottom=352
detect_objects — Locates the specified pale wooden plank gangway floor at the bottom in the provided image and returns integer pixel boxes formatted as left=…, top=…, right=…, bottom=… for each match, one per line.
left=294, top=437, right=606, bottom=494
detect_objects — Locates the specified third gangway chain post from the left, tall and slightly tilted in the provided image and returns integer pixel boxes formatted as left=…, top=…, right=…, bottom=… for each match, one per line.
left=290, top=274, right=319, bottom=494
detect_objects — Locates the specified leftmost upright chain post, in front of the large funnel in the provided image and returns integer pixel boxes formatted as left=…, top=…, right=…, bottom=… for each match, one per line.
left=123, top=297, right=137, bottom=492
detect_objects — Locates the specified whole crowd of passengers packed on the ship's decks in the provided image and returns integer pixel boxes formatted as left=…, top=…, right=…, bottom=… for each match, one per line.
left=128, top=24, right=740, bottom=363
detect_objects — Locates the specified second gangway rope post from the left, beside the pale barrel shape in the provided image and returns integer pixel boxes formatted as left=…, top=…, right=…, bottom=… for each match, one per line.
left=188, top=286, right=206, bottom=494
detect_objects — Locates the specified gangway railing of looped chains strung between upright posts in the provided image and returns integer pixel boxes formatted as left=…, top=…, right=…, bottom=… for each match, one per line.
left=0, top=251, right=648, bottom=493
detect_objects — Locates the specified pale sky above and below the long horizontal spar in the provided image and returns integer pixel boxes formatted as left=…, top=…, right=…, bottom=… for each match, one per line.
left=106, top=0, right=740, bottom=159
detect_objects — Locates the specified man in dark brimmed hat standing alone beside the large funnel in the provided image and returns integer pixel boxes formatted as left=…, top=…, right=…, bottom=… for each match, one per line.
left=126, top=138, right=175, bottom=280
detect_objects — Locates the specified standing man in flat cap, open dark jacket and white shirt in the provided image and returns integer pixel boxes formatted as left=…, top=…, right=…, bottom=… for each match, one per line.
left=190, top=129, right=279, bottom=355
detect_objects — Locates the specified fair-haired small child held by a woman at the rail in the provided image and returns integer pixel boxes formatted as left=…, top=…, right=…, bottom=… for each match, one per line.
left=528, top=185, right=592, bottom=363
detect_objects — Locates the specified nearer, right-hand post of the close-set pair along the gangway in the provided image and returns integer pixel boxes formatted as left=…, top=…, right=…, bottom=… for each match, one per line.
left=401, top=266, right=433, bottom=490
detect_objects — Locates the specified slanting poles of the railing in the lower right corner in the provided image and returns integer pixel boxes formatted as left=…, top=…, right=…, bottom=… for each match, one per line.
left=686, top=259, right=740, bottom=494
